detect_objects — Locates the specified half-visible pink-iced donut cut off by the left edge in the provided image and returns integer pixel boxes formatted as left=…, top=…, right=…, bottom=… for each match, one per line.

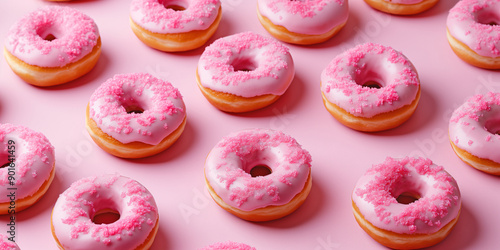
left=0, top=124, right=55, bottom=214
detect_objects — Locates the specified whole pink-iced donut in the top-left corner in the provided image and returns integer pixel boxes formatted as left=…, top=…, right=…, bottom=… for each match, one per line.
left=4, top=6, right=101, bottom=87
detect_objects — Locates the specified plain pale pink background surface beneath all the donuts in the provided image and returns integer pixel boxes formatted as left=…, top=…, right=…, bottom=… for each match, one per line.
left=0, top=0, right=500, bottom=250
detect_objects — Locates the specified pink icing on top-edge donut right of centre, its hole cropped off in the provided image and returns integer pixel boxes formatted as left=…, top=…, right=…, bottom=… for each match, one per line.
left=257, top=0, right=349, bottom=35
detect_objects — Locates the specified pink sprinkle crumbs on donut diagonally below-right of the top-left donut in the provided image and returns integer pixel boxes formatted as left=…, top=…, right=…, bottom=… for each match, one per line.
left=89, top=73, right=184, bottom=136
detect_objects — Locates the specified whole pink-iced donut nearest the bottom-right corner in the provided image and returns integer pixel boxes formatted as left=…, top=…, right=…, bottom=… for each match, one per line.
left=352, top=157, right=461, bottom=249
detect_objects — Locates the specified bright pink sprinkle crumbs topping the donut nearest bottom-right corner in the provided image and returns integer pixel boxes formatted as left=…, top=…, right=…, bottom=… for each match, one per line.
left=354, top=157, right=460, bottom=233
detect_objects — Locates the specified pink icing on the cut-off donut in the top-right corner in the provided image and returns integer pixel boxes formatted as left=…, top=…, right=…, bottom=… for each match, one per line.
left=446, top=0, right=500, bottom=58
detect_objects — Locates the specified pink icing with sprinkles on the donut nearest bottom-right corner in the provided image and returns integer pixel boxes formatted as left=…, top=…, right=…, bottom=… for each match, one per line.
left=352, top=157, right=461, bottom=234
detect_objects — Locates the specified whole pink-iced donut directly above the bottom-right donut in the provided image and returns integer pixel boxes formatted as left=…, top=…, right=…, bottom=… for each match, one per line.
left=321, top=43, right=420, bottom=132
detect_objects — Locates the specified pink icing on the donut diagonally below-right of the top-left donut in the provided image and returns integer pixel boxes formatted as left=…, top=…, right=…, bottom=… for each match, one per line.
left=89, top=73, right=186, bottom=145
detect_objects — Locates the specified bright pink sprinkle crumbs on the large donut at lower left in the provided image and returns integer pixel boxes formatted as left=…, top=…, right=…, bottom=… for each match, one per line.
left=59, top=175, right=157, bottom=245
